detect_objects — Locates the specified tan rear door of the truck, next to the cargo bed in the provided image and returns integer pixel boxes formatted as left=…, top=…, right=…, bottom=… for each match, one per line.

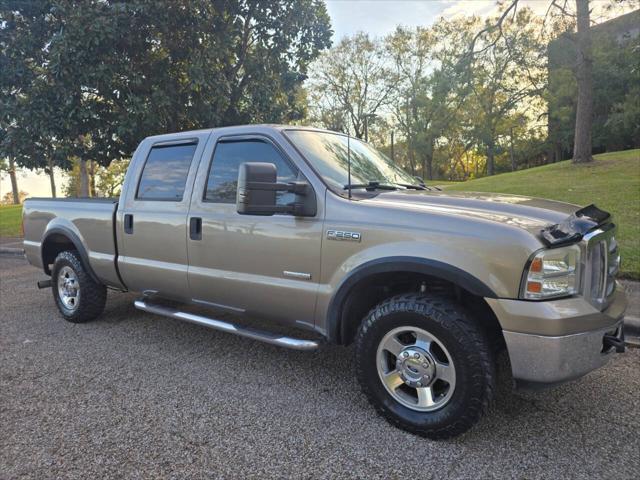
left=116, top=132, right=210, bottom=300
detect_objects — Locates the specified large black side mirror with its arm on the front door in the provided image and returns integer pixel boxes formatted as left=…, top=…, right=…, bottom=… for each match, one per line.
left=236, top=162, right=317, bottom=217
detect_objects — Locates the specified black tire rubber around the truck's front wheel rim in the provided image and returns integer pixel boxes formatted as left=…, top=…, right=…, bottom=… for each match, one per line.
left=355, top=294, right=495, bottom=440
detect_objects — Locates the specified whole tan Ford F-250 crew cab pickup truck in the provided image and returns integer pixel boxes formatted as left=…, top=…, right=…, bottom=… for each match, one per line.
left=24, top=125, right=626, bottom=439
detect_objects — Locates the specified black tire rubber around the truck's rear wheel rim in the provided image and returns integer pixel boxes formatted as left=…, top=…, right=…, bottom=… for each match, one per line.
left=51, top=251, right=107, bottom=323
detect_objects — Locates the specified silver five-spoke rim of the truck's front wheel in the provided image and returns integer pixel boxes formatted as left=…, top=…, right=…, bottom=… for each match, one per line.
left=376, top=326, right=456, bottom=412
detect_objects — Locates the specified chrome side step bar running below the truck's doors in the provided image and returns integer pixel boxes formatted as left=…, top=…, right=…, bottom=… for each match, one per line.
left=133, top=299, right=319, bottom=350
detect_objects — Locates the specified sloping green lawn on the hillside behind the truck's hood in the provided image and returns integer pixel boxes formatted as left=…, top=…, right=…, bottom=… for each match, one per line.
left=445, top=150, right=640, bottom=280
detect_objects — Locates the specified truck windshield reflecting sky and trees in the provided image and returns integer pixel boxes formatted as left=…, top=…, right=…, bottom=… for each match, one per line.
left=287, top=130, right=418, bottom=190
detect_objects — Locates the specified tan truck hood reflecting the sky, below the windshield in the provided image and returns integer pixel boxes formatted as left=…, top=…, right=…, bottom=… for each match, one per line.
left=364, top=190, right=580, bottom=238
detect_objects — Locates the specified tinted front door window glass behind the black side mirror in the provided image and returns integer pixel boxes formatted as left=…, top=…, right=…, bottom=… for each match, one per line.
left=204, top=140, right=296, bottom=204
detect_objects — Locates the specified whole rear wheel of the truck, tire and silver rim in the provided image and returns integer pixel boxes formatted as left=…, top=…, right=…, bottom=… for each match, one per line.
left=51, top=251, right=107, bottom=323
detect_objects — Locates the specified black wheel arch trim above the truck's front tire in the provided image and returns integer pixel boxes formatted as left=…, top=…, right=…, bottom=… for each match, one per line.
left=326, top=256, right=501, bottom=345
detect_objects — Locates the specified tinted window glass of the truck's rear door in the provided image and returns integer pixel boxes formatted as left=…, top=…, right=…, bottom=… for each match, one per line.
left=136, top=142, right=197, bottom=202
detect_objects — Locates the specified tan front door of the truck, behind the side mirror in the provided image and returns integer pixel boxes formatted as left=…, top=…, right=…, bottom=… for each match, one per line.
left=187, top=133, right=322, bottom=326
